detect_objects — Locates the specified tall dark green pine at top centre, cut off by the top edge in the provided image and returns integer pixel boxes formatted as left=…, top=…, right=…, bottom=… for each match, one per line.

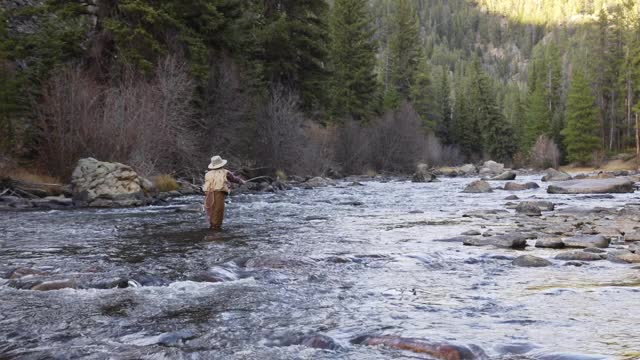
left=329, top=0, right=377, bottom=120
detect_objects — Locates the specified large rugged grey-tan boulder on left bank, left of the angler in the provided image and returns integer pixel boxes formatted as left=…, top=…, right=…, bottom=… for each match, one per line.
left=71, top=158, right=152, bottom=207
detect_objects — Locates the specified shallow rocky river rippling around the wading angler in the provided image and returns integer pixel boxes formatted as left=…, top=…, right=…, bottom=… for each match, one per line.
left=0, top=175, right=640, bottom=360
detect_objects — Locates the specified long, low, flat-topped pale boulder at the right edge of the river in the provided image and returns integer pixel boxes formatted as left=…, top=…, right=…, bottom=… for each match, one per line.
left=547, top=177, right=635, bottom=194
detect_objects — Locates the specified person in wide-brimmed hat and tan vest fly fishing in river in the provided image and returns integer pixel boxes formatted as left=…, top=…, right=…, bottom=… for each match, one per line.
left=202, top=155, right=245, bottom=231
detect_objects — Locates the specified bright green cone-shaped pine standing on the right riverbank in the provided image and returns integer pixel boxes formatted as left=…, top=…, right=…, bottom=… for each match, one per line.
left=562, top=72, right=601, bottom=164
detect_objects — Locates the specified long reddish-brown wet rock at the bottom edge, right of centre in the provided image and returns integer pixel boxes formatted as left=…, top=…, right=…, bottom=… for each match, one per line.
left=351, top=335, right=488, bottom=360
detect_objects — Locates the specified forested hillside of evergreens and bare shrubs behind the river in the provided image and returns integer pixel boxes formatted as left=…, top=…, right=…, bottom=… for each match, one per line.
left=0, top=0, right=640, bottom=177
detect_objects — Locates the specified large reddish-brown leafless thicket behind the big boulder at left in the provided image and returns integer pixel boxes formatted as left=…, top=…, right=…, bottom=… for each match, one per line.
left=38, top=58, right=196, bottom=177
